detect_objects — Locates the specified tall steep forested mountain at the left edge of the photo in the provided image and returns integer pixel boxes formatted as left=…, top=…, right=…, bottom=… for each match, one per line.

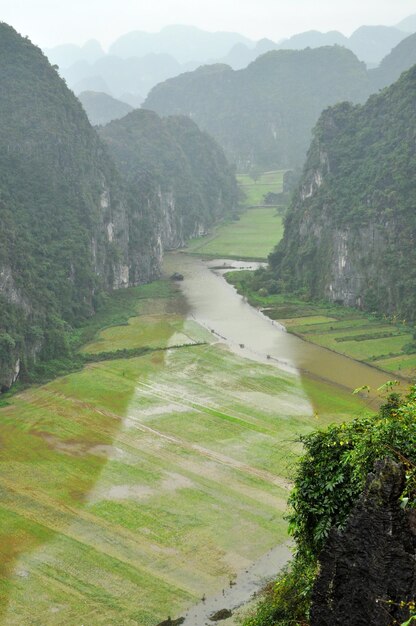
left=0, top=24, right=141, bottom=388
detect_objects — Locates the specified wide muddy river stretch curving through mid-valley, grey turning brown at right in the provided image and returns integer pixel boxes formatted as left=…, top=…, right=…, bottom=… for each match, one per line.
left=165, top=253, right=391, bottom=390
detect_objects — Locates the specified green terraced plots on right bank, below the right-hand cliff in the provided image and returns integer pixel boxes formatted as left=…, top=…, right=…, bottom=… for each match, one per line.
left=227, top=272, right=416, bottom=379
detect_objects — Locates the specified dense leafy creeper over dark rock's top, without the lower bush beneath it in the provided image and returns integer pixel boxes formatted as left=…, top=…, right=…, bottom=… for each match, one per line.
left=289, top=388, right=416, bottom=557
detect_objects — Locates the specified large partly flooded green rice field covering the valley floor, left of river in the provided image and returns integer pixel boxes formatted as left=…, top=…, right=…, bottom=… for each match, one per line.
left=0, top=282, right=362, bottom=626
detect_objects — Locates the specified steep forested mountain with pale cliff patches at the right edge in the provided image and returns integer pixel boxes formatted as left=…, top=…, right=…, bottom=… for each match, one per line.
left=270, top=66, right=416, bottom=320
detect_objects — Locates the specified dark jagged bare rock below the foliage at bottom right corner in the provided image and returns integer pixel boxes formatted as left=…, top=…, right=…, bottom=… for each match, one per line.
left=311, top=459, right=416, bottom=626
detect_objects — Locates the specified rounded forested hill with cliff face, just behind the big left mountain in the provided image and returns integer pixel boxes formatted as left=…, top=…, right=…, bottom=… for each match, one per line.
left=100, top=110, right=237, bottom=248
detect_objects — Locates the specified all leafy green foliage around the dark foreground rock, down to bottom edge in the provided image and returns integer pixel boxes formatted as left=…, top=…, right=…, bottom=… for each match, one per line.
left=244, top=387, right=416, bottom=626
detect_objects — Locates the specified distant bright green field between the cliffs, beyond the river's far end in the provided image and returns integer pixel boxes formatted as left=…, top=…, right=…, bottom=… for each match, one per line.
left=187, top=171, right=285, bottom=261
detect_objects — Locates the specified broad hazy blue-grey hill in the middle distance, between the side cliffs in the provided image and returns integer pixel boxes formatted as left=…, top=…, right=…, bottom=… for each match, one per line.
left=144, top=46, right=369, bottom=170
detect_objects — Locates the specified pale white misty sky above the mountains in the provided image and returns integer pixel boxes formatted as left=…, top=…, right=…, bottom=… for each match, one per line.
left=0, top=0, right=416, bottom=47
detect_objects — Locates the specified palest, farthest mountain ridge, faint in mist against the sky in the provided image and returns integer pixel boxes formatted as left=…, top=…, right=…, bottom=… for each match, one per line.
left=45, top=16, right=416, bottom=104
